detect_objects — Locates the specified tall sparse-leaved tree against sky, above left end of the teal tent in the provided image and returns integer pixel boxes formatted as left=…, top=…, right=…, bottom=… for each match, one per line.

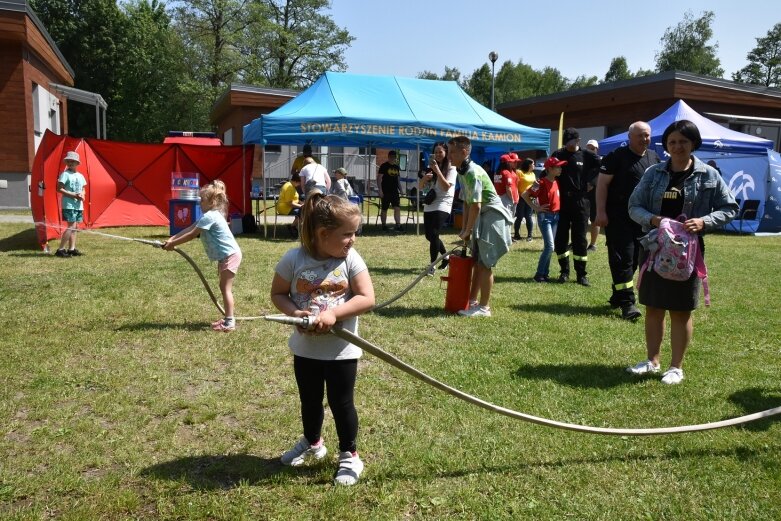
left=242, top=0, right=355, bottom=88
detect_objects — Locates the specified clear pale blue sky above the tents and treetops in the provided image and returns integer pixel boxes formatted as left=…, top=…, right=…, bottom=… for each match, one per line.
left=330, top=0, right=781, bottom=80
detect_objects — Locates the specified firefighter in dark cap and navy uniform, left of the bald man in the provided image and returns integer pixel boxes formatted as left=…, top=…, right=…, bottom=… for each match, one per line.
left=551, top=128, right=600, bottom=286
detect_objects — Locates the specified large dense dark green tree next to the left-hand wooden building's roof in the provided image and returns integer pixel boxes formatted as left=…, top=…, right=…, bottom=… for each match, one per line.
left=32, top=0, right=211, bottom=143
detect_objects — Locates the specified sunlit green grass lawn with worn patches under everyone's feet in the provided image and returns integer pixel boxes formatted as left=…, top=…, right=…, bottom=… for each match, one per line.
left=0, top=223, right=781, bottom=520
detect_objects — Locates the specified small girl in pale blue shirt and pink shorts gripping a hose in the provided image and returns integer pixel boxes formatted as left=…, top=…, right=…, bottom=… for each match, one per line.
left=163, top=181, right=241, bottom=332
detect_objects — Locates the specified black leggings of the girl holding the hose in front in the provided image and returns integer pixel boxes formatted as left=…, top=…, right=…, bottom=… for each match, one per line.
left=293, top=356, right=358, bottom=452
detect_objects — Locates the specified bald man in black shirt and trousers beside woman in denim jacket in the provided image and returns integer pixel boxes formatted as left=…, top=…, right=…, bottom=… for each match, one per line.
left=596, top=121, right=659, bottom=320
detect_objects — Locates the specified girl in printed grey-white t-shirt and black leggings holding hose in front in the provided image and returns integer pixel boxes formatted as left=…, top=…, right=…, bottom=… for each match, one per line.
left=271, top=192, right=374, bottom=485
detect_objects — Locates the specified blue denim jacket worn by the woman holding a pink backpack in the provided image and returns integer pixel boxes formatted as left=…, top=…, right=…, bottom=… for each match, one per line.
left=629, top=156, right=740, bottom=233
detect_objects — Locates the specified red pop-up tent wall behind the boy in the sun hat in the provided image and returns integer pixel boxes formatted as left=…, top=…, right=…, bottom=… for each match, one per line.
left=30, top=131, right=253, bottom=246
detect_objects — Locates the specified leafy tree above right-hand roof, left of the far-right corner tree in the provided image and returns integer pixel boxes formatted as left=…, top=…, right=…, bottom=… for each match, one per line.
left=656, top=11, right=724, bottom=78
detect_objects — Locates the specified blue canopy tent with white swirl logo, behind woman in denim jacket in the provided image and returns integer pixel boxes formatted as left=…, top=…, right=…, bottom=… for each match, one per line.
left=599, top=100, right=781, bottom=233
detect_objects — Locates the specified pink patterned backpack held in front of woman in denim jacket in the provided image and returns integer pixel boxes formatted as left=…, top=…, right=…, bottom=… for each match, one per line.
left=637, top=215, right=710, bottom=306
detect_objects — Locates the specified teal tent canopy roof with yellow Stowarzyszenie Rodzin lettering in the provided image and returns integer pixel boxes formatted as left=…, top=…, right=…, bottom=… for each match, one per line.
left=244, top=72, right=550, bottom=154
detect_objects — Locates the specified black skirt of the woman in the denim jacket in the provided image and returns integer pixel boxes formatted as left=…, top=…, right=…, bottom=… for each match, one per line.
left=638, top=250, right=701, bottom=311
